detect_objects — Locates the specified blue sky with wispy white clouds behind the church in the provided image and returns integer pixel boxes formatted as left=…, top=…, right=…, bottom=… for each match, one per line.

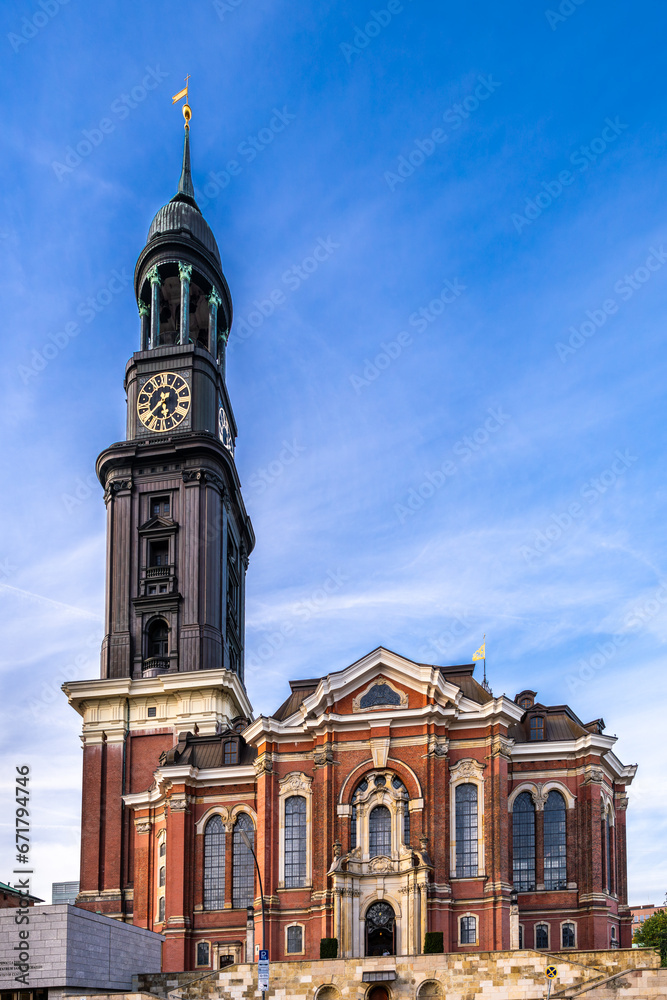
left=0, top=0, right=667, bottom=903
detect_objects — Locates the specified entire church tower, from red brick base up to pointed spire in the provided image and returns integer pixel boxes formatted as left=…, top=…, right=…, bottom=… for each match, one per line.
left=64, top=117, right=255, bottom=921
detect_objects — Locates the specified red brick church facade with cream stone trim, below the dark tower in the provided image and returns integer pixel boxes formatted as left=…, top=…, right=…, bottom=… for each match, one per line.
left=69, top=649, right=634, bottom=970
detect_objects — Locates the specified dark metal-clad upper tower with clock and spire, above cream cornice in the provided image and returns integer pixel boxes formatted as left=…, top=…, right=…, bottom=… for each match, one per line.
left=97, top=132, right=254, bottom=681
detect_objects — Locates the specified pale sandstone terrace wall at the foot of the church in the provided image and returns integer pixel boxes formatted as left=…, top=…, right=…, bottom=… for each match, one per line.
left=136, top=949, right=667, bottom=1000
